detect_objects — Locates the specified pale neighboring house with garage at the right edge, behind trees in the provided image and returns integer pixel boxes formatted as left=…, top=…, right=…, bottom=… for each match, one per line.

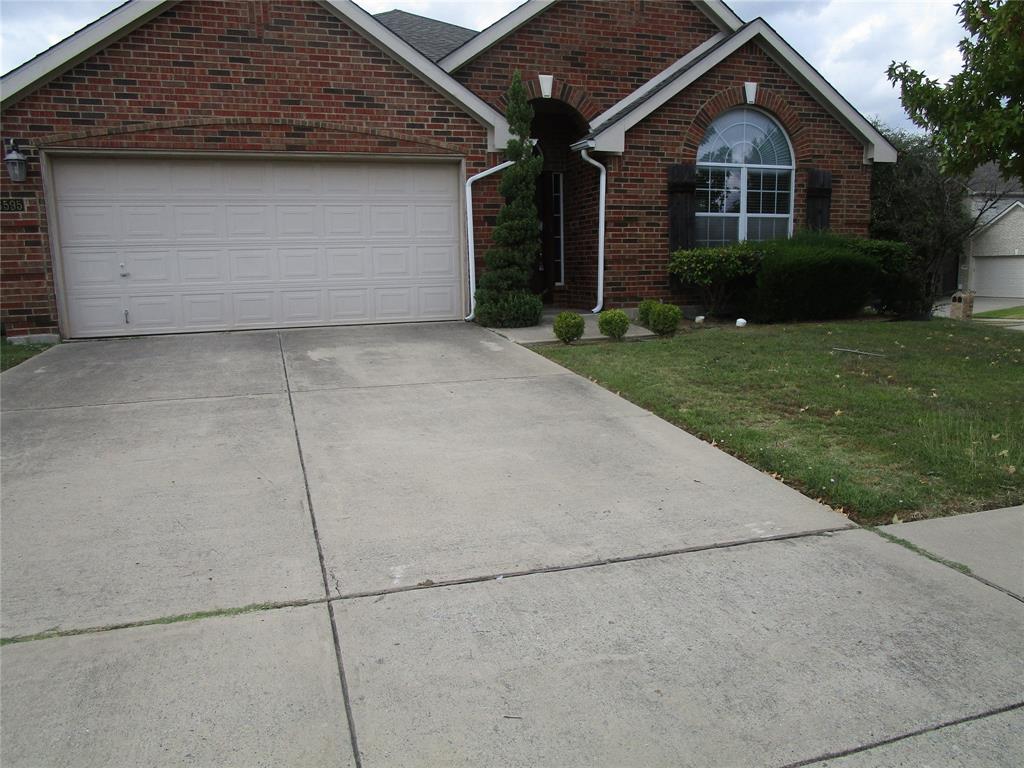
left=959, top=164, right=1024, bottom=299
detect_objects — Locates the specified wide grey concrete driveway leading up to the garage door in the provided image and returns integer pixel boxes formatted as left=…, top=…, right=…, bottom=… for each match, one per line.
left=0, top=324, right=1024, bottom=767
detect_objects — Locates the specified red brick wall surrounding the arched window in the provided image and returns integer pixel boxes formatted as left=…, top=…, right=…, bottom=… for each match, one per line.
left=605, top=43, right=871, bottom=305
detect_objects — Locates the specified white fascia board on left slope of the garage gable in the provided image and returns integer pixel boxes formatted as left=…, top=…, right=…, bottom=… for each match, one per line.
left=0, top=0, right=177, bottom=109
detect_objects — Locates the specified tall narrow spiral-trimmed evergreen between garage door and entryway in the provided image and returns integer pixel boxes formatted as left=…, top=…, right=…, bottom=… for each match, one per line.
left=476, top=72, right=544, bottom=328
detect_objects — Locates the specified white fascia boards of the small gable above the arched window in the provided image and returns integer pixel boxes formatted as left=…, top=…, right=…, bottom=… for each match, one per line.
left=593, top=18, right=896, bottom=163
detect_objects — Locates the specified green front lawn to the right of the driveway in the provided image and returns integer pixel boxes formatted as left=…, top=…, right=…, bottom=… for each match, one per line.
left=538, top=319, right=1024, bottom=523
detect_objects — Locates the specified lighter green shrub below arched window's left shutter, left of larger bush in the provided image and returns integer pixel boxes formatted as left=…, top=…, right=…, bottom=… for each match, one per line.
left=669, top=243, right=764, bottom=315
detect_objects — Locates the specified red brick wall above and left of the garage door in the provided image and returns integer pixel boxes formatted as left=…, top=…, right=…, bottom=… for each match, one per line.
left=0, top=0, right=498, bottom=336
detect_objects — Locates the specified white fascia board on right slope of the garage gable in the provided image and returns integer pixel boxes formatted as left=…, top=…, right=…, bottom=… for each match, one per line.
left=319, top=0, right=510, bottom=152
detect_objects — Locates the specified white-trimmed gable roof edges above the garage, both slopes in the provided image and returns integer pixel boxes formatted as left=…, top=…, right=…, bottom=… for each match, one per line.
left=0, top=0, right=509, bottom=150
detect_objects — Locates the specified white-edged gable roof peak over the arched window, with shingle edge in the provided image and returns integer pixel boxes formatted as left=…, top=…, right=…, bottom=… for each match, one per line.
left=578, top=17, right=896, bottom=163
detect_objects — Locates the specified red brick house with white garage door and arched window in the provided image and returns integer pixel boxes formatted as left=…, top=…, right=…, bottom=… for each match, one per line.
left=0, top=0, right=896, bottom=337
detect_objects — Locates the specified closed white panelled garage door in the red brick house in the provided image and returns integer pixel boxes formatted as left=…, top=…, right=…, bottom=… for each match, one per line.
left=53, top=158, right=462, bottom=336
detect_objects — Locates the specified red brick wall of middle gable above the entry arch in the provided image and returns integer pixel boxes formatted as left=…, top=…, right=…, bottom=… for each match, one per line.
left=454, top=0, right=719, bottom=120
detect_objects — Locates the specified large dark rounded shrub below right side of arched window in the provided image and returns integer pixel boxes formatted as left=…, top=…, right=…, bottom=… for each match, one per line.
left=756, top=233, right=882, bottom=322
